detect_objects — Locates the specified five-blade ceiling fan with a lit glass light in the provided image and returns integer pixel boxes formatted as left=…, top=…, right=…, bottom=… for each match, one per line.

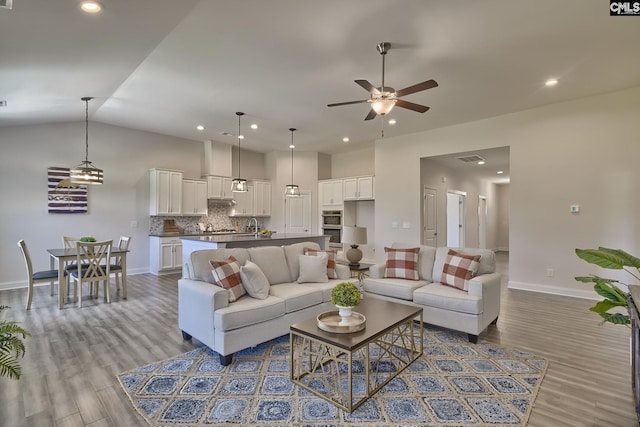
left=327, top=42, right=438, bottom=120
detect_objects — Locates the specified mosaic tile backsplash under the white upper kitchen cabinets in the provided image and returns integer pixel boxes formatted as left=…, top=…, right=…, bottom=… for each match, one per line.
left=149, top=200, right=263, bottom=235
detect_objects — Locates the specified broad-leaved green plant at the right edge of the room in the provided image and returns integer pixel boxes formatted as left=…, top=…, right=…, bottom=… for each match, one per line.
left=575, top=247, right=640, bottom=326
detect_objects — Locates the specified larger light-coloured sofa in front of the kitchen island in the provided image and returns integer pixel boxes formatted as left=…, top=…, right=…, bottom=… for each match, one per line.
left=178, top=242, right=350, bottom=365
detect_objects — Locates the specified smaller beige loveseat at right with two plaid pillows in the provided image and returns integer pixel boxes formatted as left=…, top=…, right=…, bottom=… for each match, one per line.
left=364, top=243, right=500, bottom=343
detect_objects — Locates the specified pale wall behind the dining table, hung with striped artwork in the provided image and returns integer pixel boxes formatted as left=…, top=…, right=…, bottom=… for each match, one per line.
left=0, top=122, right=203, bottom=289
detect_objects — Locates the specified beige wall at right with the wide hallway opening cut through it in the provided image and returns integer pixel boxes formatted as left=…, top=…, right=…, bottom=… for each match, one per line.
left=375, top=87, right=640, bottom=297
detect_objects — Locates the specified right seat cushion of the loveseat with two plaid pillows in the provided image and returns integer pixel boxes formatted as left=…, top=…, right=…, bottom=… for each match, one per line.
left=413, top=283, right=483, bottom=315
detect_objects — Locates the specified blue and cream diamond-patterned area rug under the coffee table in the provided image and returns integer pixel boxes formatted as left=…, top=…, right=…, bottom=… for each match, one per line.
left=118, top=327, right=548, bottom=427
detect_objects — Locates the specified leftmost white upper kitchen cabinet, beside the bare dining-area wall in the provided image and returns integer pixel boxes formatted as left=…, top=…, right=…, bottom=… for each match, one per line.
left=149, top=169, right=183, bottom=215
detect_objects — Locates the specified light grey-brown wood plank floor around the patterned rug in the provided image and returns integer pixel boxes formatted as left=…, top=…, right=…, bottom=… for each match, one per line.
left=0, top=253, right=638, bottom=427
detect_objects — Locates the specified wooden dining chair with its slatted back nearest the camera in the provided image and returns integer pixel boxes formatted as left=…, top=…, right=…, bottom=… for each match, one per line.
left=70, top=240, right=113, bottom=307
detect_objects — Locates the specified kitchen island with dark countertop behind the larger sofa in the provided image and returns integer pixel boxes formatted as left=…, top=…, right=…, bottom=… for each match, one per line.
left=181, top=233, right=329, bottom=276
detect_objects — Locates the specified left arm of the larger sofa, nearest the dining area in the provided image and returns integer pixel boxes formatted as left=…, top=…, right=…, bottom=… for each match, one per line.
left=178, top=279, right=229, bottom=338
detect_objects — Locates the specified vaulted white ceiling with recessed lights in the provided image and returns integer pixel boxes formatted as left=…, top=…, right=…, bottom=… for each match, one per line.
left=0, top=0, right=640, bottom=153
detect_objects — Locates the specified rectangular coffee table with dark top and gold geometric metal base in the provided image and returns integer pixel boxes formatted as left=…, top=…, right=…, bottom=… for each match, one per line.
left=289, top=298, right=423, bottom=412
